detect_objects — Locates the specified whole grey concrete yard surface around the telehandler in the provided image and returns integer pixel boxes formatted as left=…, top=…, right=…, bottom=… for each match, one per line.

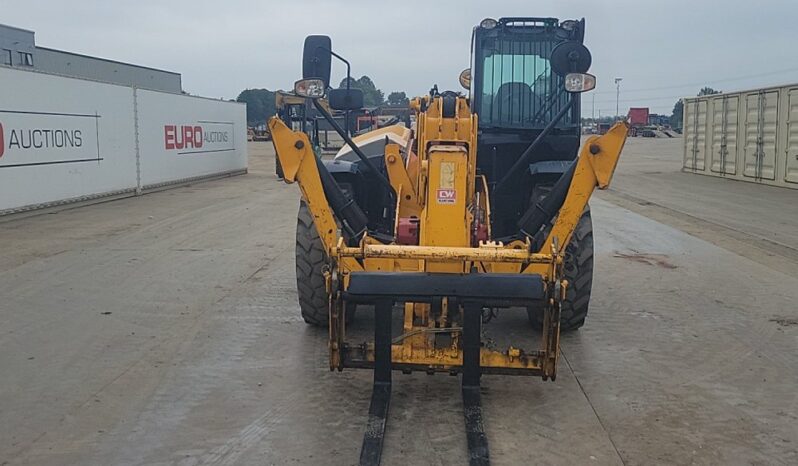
left=0, top=139, right=798, bottom=465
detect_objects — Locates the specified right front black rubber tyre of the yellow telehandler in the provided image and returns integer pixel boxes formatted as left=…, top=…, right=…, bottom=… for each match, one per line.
left=527, top=207, right=593, bottom=332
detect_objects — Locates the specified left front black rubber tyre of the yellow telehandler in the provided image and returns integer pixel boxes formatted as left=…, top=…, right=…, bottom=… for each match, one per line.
left=295, top=201, right=355, bottom=327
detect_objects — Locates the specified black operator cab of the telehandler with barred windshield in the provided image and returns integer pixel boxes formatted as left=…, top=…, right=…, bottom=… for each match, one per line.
left=468, top=17, right=595, bottom=237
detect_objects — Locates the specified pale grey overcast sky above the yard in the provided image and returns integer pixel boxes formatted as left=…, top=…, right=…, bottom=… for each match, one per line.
left=6, top=0, right=798, bottom=116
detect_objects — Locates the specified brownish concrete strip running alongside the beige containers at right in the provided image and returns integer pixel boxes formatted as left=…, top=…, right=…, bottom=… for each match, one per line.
left=599, top=138, right=798, bottom=273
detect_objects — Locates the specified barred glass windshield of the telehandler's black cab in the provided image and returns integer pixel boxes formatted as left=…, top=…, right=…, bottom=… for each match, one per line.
left=479, top=36, right=570, bottom=128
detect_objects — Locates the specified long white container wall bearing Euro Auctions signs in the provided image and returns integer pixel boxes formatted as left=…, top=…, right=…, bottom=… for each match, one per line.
left=0, top=66, right=247, bottom=215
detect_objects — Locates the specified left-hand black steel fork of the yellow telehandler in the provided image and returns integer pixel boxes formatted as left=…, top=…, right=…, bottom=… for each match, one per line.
left=360, top=300, right=393, bottom=466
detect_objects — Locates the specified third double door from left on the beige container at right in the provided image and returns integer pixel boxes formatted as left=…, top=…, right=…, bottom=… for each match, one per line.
left=743, top=91, right=779, bottom=180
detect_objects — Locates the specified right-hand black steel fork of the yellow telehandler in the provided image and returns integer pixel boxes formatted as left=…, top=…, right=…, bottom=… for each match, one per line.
left=462, top=303, right=490, bottom=466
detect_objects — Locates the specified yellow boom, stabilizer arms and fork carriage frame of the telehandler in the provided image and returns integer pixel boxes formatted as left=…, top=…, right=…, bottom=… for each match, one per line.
left=269, top=97, right=628, bottom=379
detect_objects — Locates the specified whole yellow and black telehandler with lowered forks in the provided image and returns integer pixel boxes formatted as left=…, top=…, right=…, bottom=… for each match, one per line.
left=269, top=18, right=628, bottom=464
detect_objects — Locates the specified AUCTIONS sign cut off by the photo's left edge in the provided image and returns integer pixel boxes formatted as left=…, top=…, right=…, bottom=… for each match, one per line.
left=0, top=109, right=102, bottom=167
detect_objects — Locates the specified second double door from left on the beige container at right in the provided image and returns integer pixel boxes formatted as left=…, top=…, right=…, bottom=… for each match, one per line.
left=710, top=95, right=740, bottom=175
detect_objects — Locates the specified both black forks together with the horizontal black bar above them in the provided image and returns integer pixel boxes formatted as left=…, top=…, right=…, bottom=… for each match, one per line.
left=344, top=272, right=544, bottom=466
